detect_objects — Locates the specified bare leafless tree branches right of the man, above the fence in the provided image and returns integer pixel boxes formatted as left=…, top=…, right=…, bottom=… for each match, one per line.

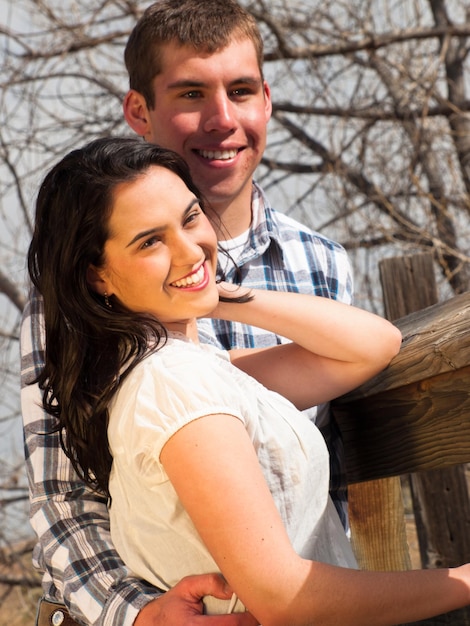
left=250, top=0, right=470, bottom=307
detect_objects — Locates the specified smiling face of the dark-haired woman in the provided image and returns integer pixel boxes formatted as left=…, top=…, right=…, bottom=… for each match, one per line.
left=94, top=166, right=222, bottom=334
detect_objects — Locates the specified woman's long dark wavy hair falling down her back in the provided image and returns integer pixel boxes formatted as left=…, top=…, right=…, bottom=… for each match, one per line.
left=28, top=138, right=229, bottom=494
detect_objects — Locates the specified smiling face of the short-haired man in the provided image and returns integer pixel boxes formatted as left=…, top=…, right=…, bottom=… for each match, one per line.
left=129, top=39, right=271, bottom=211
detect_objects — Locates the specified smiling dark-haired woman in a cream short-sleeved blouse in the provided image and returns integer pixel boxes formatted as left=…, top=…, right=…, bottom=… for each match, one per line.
left=28, top=139, right=470, bottom=626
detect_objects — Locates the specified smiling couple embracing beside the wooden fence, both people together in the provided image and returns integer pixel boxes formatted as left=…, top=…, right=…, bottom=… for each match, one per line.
left=22, top=0, right=468, bottom=626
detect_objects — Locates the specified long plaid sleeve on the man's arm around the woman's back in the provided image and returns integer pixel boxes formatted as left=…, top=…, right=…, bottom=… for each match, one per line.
left=21, top=293, right=162, bottom=626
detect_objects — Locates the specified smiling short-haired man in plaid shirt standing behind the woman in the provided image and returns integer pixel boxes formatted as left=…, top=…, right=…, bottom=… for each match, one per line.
left=22, top=0, right=351, bottom=626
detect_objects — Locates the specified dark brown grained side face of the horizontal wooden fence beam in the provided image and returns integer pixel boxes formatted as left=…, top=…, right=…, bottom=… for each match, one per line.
left=334, top=366, right=470, bottom=482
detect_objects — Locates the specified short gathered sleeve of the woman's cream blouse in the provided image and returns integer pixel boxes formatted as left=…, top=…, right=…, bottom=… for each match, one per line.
left=108, top=340, right=246, bottom=476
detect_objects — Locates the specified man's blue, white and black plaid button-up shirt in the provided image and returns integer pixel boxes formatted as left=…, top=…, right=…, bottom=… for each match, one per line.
left=21, top=180, right=352, bottom=626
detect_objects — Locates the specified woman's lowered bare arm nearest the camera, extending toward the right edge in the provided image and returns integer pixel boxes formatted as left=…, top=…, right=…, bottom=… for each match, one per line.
left=161, top=415, right=470, bottom=626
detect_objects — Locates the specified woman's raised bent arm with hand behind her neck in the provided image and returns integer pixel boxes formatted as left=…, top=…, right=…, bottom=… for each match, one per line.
left=212, top=284, right=401, bottom=409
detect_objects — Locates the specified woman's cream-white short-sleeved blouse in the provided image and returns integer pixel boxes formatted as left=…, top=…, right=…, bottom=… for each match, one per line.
left=108, top=336, right=357, bottom=614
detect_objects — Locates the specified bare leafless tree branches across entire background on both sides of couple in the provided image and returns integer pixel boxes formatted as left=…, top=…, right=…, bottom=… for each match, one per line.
left=0, top=0, right=470, bottom=616
